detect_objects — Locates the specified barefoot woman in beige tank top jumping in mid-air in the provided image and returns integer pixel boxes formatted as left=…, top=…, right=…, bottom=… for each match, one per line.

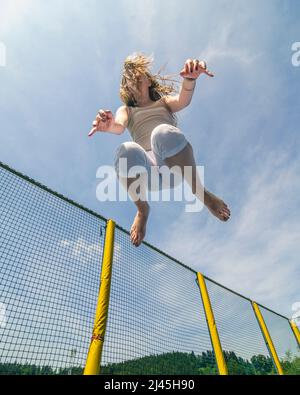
left=89, top=53, right=230, bottom=247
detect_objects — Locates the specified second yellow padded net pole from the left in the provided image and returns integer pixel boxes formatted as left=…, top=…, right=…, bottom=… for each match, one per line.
left=197, top=273, right=228, bottom=375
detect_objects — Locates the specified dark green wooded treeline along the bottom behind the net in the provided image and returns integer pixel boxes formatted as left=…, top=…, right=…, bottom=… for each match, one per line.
left=0, top=351, right=300, bottom=375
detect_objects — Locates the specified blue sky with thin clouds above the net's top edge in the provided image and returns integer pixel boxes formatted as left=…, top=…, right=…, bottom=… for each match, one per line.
left=0, top=0, right=300, bottom=322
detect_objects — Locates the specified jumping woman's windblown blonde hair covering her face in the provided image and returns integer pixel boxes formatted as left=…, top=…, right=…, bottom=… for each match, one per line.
left=120, top=52, right=178, bottom=124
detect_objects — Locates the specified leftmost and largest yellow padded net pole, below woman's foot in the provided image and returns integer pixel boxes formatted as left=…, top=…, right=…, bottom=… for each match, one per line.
left=83, top=220, right=115, bottom=375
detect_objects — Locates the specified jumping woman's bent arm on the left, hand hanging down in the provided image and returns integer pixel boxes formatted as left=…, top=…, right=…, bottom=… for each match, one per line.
left=89, top=106, right=128, bottom=137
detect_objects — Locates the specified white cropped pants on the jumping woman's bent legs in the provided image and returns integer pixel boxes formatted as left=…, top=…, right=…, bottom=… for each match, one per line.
left=114, top=124, right=188, bottom=191
